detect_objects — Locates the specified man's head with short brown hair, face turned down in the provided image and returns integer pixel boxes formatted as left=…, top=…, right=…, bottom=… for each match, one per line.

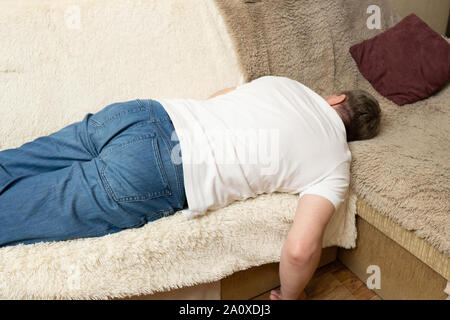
left=326, top=90, right=381, bottom=141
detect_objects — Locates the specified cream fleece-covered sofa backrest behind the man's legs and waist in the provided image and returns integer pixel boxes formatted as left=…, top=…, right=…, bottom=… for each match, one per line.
left=0, top=0, right=243, bottom=150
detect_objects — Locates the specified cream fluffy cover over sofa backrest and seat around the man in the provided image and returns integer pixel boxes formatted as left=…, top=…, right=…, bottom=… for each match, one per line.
left=0, top=0, right=356, bottom=299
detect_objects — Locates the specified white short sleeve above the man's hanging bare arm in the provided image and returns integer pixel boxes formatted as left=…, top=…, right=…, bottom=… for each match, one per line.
left=299, top=161, right=350, bottom=210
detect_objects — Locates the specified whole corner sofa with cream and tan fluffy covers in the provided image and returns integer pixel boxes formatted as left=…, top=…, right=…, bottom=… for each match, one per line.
left=0, top=0, right=450, bottom=299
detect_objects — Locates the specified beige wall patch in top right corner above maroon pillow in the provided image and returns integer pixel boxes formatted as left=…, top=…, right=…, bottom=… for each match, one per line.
left=390, top=0, right=450, bottom=34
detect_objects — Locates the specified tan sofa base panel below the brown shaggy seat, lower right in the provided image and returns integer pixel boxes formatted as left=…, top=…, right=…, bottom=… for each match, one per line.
left=338, top=216, right=447, bottom=300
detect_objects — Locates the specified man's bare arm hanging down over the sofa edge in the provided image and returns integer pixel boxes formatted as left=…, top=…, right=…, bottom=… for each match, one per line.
left=271, top=194, right=335, bottom=300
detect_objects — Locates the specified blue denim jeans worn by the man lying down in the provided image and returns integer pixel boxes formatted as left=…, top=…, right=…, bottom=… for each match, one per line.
left=0, top=100, right=187, bottom=246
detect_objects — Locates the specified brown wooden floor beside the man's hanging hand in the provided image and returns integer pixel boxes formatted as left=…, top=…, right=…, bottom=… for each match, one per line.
left=253, top=260, right=381, bottom=300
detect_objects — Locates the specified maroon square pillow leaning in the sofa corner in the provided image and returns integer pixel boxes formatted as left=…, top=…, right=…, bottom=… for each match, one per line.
left=350, top=14, right=450, bottom=106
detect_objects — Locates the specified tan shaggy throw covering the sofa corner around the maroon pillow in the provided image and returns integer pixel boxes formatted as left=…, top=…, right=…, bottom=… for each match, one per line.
left=216, top=0, right=450, bottom=257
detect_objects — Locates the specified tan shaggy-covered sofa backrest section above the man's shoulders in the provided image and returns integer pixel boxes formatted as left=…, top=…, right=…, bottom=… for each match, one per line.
left=216, top=0, right=399, bottom=94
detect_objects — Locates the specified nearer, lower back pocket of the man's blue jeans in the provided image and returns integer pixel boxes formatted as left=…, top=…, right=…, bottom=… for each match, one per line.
left=100, top=132, right=171, bottom=202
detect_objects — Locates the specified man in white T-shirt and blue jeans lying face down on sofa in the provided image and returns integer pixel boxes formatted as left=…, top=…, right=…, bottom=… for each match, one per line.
left=0, top=76, right=381, bottom=299
